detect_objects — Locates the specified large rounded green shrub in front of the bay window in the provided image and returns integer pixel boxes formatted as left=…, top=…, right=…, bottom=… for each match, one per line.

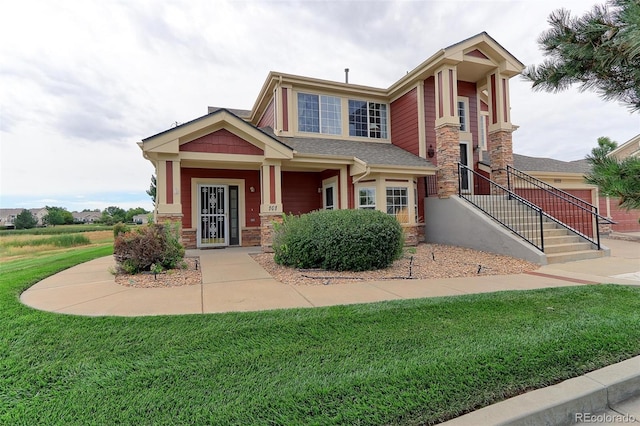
left=273, top=210, right=404, bottom=271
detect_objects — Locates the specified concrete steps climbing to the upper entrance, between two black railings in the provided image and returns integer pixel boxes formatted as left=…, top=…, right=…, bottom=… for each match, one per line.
left=465, top=195, right=608, bottom=264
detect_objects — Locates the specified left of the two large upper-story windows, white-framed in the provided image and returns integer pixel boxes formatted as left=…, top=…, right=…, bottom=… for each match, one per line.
left=298, top=93, right=342, bottom=135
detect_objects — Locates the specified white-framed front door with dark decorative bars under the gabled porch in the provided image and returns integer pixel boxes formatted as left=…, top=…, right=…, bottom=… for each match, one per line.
left=198, top=185, right=229, bottom=247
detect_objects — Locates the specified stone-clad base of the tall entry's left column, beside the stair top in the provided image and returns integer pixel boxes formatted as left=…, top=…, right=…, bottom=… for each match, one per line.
left=436, top=125, right=460, bottom=198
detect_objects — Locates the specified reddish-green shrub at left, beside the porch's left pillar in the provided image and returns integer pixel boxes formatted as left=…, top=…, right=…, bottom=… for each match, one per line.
left=113, top=224, right=184, bottom=274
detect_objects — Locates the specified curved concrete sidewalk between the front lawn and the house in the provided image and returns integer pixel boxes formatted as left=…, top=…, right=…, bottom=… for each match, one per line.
left=20, top=240, right=640, bottom=316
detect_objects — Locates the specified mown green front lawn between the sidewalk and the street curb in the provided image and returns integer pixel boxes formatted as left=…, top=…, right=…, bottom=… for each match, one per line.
left=0, top=246, right=640, bottom=425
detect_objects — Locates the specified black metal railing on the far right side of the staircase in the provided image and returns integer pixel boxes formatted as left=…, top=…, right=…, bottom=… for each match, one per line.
left=506, top=165, right=614, bottom=249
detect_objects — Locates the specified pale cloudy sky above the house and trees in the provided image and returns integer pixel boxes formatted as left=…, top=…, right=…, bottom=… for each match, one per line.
left=0, top=0, right=640, bottom=210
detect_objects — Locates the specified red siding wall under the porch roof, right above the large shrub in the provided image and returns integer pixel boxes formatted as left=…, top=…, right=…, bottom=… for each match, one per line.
left=282, top=172, right=322, bottom=214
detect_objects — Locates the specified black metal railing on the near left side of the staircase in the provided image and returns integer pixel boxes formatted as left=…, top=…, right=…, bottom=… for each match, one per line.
left=458, top=163, right=552, bottom=252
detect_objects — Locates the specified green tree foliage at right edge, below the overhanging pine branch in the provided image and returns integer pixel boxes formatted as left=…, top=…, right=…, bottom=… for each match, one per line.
left=585, top=137, right=640, bottom=210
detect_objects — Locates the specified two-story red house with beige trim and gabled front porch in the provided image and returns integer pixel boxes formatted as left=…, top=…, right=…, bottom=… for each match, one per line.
left=139, top=32, right=524, bottom=250
